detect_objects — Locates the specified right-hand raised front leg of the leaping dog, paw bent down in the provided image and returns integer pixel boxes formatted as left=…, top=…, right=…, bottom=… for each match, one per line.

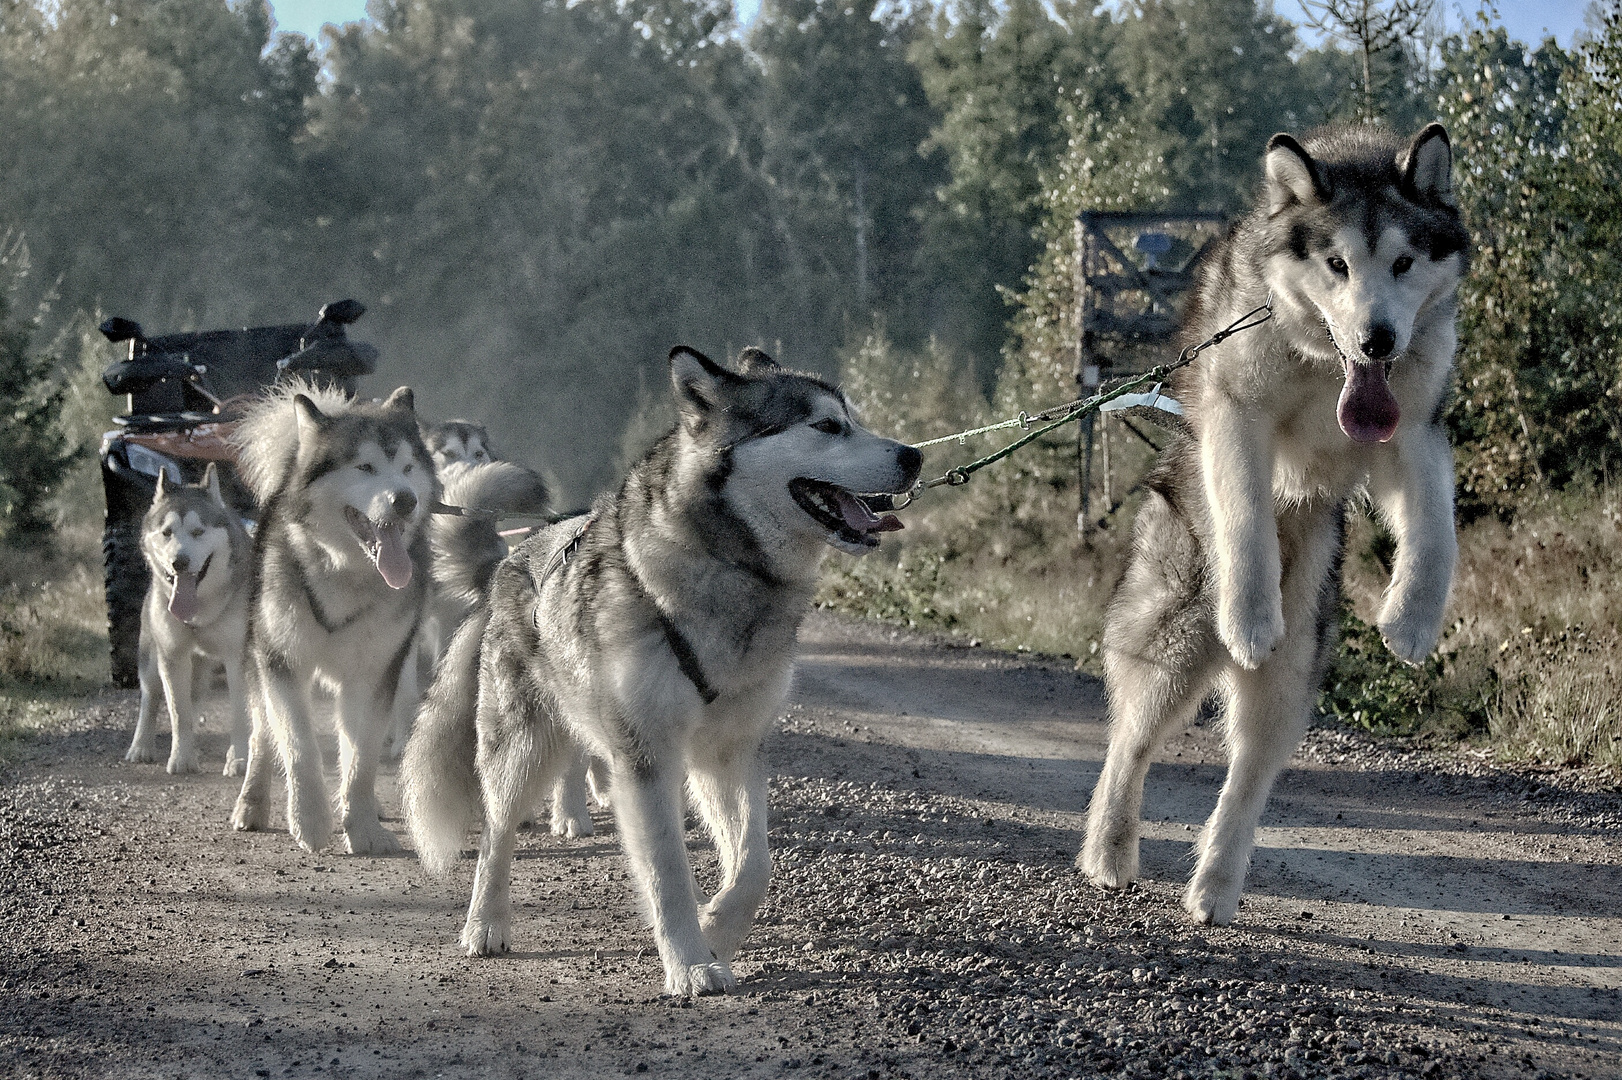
left=1369, top=423, right=1458, bottom=663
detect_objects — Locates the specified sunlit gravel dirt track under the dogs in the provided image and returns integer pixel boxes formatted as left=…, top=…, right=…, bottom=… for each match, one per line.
left=0, top=618, right=1622, bottom=1080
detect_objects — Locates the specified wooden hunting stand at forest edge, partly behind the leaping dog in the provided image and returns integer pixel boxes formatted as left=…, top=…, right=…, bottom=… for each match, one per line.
left=1075, top=211, right=1225, bottom=537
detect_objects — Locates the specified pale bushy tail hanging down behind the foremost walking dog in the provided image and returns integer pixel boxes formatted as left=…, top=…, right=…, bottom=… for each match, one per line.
left=401, top=606, right=490, bottom=874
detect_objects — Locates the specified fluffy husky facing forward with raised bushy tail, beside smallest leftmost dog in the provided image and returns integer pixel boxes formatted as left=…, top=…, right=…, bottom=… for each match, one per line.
left=232, top=383, right=440, bottom=855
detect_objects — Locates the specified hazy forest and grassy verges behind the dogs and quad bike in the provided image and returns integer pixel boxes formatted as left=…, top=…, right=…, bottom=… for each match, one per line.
left=0, top=0, right=1622, bottom=777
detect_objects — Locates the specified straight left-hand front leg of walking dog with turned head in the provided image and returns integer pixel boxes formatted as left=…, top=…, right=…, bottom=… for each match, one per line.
left=611, top=748, right=736, bottom=997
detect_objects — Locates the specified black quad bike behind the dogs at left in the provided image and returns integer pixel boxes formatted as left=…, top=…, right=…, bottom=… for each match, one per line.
left=101, top=300, right=378, bottom=688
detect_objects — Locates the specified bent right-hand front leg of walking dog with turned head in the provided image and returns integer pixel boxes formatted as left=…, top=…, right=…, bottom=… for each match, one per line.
left=688, top=739, right=772, bottom=963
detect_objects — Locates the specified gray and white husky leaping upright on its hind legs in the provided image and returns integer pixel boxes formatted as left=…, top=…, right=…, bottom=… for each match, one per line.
left=1077, top=123, right=1468, bottom=924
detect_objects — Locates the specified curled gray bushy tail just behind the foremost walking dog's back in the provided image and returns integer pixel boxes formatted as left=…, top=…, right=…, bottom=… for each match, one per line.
left=428, top=461, right=547, bottom=608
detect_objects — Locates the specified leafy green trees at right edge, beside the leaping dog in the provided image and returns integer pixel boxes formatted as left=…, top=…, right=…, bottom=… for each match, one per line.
left=1442, top=21, right=1622, bottom=516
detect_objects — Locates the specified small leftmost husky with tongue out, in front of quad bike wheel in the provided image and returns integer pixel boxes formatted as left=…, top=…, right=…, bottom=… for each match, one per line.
left=123, top=462, right=253, bottom=777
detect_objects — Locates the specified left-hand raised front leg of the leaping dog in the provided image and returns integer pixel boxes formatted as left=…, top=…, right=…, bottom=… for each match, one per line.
left=1200, top=394, right=1285, bottom=670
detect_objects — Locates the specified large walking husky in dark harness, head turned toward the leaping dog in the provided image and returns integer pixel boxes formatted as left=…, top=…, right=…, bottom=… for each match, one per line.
left=402, top=347, right=921, bottom=994
